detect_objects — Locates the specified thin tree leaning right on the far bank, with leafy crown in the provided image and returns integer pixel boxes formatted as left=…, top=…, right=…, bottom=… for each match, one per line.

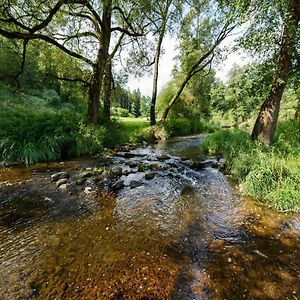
left=160, top=1, right=238, bottom=125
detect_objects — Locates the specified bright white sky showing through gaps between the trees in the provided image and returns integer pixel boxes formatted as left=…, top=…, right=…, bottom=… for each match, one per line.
left=127, top=36, right=250, bottom=96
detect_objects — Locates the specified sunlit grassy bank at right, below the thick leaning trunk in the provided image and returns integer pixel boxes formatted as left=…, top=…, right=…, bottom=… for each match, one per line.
left=202, top=121, right=300, bottom=212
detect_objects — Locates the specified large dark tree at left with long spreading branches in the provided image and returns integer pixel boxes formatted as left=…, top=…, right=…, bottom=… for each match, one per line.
left=0, top=0, right=143, bottom=124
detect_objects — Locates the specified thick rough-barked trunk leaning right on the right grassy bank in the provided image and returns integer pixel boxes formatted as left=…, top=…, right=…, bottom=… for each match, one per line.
left=251, top=0, right=300, bottom=146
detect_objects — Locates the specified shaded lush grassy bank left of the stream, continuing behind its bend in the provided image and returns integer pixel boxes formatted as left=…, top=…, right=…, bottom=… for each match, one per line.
left=0, top=86, right=216, bottom=165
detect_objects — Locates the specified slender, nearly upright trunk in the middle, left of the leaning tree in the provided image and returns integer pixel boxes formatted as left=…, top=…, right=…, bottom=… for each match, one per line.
left=150, top=20, right=167, bottom=125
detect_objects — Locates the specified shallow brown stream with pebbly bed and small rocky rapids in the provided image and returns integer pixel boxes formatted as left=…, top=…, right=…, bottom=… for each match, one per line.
left=0, top=136, right=300, bottom=300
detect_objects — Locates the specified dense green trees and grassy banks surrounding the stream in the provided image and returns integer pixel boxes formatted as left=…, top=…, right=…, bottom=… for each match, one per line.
left=0, top=0, right=300, bottom=210
